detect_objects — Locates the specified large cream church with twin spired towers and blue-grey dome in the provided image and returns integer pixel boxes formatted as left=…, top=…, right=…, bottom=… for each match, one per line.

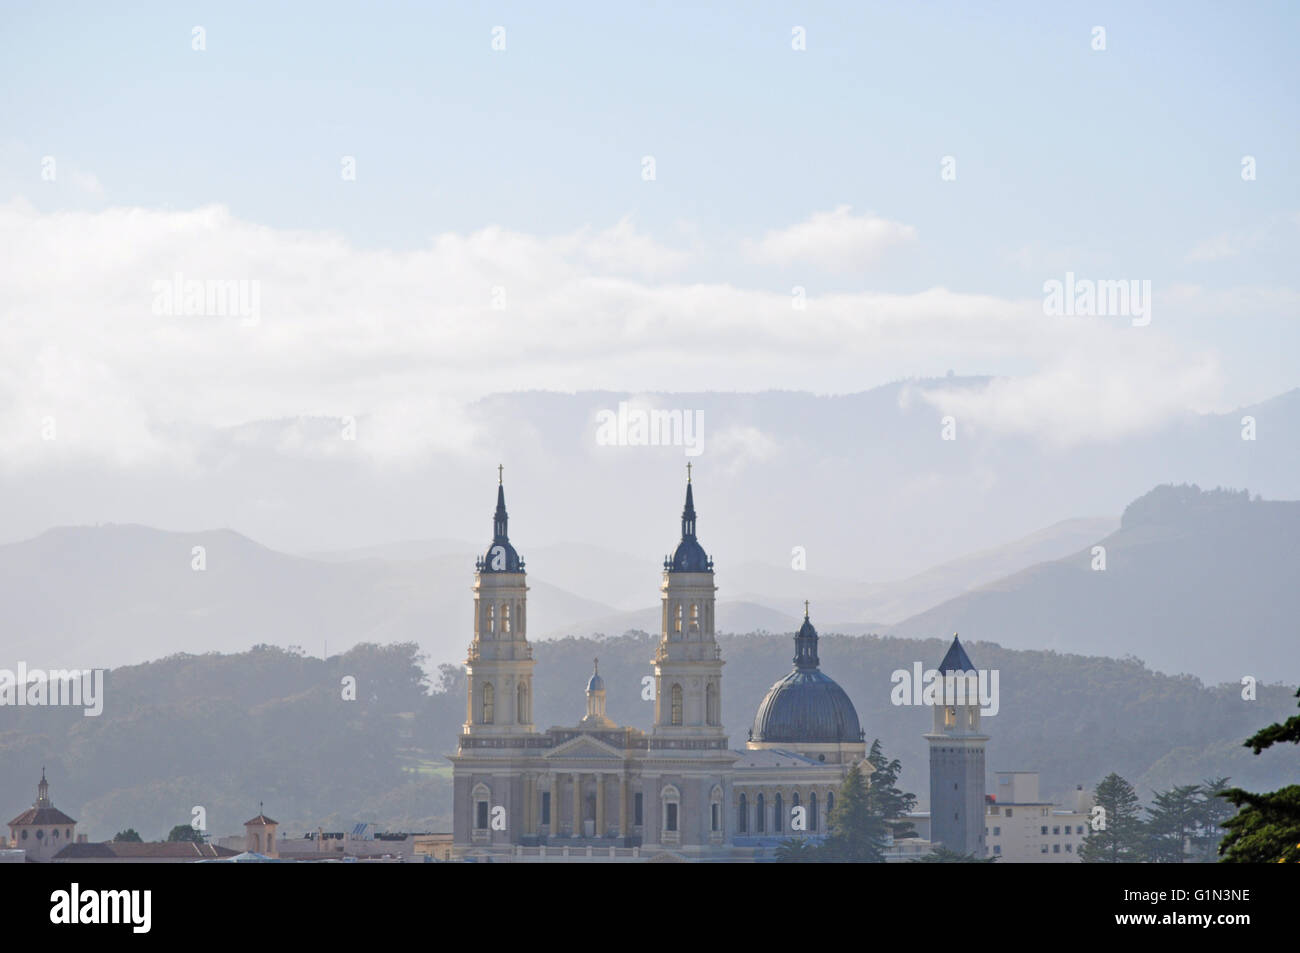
left=450, top=473, right=866, bottom=862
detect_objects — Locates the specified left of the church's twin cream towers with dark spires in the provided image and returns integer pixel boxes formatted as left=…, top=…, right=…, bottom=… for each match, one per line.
left=464, top=467, right=534, bottom=735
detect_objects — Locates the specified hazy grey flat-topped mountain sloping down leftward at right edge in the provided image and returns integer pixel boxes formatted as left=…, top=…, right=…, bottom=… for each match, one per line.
left=885, top=485, right=1300, bottom=684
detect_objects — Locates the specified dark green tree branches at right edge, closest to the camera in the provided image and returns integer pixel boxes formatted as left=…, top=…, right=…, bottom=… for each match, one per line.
left=1219, top=690, right=1300, bottom=863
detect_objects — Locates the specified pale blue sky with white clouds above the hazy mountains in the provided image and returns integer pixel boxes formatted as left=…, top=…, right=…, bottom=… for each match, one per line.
left=0, top=3, right=1300, bottom=546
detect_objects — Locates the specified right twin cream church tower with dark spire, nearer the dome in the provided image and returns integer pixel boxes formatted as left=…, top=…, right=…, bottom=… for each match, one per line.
left=654, top=463, right=725, bottom=746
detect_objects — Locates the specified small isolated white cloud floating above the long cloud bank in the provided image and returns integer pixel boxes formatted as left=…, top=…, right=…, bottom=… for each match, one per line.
left=749, top=205, right=917, bottom=272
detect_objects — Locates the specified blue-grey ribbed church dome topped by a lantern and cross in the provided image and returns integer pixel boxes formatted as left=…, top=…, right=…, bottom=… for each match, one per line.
left=750, top=612, right=863, bottom=745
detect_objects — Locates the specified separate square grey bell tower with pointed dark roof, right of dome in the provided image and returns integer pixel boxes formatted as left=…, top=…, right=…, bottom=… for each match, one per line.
left=926, top=634, right=988, bottom=858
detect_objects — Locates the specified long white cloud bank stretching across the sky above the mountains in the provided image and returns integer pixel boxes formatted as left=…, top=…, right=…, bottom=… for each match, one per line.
left=0, top=202, right=1218, bottom=469
